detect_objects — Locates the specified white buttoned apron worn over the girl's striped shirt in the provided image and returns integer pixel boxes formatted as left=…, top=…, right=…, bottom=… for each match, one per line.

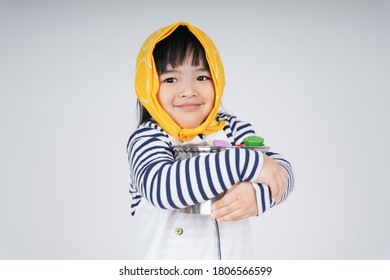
left=135, top=131, right=253, bottom=260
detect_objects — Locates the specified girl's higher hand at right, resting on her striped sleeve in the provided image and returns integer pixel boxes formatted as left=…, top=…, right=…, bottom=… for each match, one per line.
left=256, top=155, right=288, bottom=203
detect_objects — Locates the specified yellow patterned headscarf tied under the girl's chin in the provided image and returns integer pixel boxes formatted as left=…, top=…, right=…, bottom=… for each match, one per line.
left=134, top=22, right=225, bottom=141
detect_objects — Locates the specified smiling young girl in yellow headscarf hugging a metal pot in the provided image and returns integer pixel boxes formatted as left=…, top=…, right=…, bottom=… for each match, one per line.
left=127, top=22, right=293, bottom=259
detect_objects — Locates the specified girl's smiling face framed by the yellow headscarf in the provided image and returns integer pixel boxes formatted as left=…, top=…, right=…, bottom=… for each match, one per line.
left=157, top=57, right=215, bottom=128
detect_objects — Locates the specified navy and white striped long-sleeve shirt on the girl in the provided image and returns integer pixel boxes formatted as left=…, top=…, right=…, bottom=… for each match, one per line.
left=127, top=113, right=294, bottom=215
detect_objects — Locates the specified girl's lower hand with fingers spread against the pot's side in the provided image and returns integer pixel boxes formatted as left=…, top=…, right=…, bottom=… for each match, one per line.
left=211, top=182, right=259, bottom=222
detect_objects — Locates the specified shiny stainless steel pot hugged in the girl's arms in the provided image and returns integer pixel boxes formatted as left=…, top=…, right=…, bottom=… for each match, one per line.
left=173, top=145, right=269, bottom=215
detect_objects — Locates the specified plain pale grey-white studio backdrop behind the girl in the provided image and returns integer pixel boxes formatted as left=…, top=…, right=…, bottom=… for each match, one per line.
left=0, top=0, right=390, bottom=259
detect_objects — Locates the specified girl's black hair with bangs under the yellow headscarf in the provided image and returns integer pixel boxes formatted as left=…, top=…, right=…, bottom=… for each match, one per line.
left=137, top=25, right=209, bottom=125
